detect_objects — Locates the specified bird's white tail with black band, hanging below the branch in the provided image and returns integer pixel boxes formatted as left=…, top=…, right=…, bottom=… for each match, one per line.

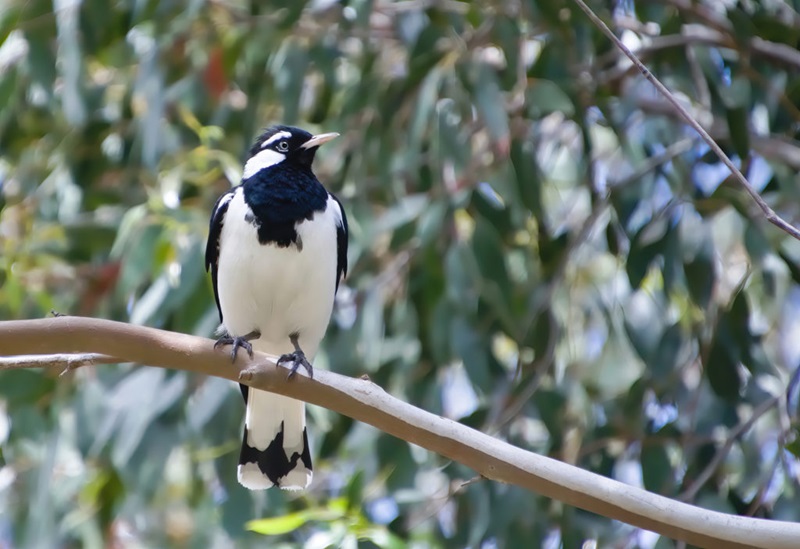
left=238, top=386, right=311, bottom=490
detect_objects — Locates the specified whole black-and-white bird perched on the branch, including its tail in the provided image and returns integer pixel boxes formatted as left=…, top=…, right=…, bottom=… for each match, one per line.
left=206, top=126, right=347, bottom=490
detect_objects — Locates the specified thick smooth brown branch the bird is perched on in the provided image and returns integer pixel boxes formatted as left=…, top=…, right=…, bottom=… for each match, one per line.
left=0, top=316, right=800, bottom=549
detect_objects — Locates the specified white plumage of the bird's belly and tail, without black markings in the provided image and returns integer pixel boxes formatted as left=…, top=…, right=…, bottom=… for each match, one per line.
left=217, top=187, right=342, bottom=489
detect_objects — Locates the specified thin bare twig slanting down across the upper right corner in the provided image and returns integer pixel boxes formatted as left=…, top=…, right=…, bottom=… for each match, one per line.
left=574, top=0, right=800, bottom=240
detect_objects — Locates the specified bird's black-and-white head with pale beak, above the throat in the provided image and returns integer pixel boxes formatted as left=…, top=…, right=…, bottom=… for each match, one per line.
left=242, top=126, right=339, bottom=180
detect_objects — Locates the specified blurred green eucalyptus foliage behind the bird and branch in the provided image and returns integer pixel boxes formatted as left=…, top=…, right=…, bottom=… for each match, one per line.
left=0, top=0, right=800, bottom=549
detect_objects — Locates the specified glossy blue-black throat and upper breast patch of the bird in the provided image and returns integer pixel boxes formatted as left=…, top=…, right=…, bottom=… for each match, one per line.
left=242, top=162, right=328, bottom=249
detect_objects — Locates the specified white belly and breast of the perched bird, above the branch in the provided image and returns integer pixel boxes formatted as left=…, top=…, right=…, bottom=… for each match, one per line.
left=217, top=188, right=338, bottom=360
